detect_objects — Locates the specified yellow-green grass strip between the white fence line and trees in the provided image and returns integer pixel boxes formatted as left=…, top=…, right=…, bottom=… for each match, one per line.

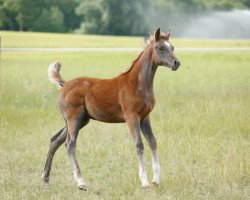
left=0, top=31, right=250, bottom=48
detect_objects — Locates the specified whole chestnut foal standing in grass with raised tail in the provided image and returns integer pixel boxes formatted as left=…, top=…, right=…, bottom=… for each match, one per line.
left=42, top=28, right=180, bottom=190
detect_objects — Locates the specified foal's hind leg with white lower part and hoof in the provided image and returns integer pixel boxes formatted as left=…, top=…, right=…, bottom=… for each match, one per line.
left=66, top=111, right=89, bottom=190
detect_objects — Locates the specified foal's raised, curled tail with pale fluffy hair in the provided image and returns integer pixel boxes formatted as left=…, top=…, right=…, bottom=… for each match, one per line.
left=48, top=62, right=66, bottom=86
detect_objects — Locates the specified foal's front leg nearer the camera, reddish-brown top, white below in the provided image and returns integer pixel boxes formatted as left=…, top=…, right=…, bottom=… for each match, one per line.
left=125, top=114, right=150, bottom=188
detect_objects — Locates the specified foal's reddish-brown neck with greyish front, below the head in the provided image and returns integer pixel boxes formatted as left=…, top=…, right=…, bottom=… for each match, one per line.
left=129, top=44, right=157, bottom=91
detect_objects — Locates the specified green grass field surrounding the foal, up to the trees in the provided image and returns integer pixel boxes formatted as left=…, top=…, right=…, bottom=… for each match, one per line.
left=0, top=32, right=250, bottom=200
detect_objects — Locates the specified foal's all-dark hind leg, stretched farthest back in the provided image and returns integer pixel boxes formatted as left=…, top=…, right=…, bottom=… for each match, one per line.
left=43, top=128, right=67, bottom=183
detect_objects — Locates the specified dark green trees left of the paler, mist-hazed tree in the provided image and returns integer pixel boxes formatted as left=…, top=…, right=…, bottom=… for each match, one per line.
left=0, top=0, right=79, bottom=32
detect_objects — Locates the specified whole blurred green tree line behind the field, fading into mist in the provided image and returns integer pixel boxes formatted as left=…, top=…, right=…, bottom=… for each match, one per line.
left=0, top=0, right=250, bottom=35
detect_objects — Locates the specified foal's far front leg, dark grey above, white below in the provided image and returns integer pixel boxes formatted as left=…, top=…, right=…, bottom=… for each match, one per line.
left=140, top=118, right=160, bottom=186
